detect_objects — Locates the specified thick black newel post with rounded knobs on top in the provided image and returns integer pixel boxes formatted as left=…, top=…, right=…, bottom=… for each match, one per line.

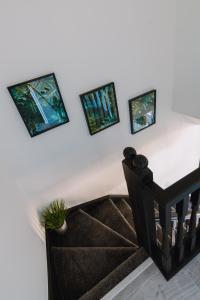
left=122, top=147, right=156, bottom=255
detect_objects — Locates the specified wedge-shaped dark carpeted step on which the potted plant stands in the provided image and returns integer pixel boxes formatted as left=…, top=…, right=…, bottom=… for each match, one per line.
left=48, top=209, right=134, bottom=247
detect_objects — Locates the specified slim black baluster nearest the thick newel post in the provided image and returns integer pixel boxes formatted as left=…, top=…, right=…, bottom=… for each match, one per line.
left=160, top=207, right=172, bottom=273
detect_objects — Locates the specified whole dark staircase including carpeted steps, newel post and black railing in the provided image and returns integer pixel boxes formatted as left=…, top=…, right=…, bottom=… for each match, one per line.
left=46, top=147, right=200, bottom=300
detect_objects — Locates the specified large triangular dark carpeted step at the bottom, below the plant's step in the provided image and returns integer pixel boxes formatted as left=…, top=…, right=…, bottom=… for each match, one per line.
left=52, top=247, right=135, bottom=300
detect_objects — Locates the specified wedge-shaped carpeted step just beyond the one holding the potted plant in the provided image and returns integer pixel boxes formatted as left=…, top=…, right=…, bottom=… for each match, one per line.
left=87, top=199, right=137, bottom=243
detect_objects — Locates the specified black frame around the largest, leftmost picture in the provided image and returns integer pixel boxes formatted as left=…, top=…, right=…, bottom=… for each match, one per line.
left=7, top=73, right=69, bottom=137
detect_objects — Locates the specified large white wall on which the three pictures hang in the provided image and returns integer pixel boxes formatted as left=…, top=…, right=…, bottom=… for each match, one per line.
left=0, top=0, right=199, bottom=300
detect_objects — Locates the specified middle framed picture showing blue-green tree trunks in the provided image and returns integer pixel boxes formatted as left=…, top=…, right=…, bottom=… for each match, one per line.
left=80, top=82, right=119, bottom=135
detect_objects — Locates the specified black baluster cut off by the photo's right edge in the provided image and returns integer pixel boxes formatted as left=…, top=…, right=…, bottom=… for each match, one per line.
left=189, top=190, right=200, bottom=251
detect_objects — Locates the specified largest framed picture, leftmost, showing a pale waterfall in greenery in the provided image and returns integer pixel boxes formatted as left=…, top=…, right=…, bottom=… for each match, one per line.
left=8, top=73, right=69, bottom=137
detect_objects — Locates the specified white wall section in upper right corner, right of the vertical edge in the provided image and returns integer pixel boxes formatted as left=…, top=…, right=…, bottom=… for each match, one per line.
left=174, top=0, right=200, bottom=118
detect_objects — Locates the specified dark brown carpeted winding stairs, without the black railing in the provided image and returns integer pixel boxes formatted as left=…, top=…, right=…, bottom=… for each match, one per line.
left=46, top=196, right=148, bottom=300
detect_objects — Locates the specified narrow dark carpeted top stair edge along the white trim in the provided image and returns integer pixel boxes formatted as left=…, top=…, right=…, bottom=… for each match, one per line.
left=79, top=248, right=148, bottom=300
